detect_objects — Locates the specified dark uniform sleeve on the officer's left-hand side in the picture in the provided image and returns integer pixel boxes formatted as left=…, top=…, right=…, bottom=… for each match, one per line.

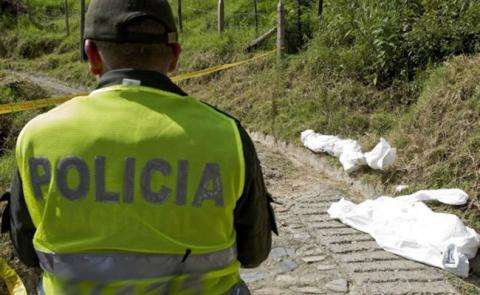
left=2, top=171, right=39, bottom=267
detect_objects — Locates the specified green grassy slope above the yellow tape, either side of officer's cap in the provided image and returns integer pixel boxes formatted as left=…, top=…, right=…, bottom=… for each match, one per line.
left=0, top=0, right=282, bottom=86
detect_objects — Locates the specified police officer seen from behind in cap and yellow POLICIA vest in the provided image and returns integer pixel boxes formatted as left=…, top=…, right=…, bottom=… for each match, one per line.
left=3, top=0, right=276, bottom=294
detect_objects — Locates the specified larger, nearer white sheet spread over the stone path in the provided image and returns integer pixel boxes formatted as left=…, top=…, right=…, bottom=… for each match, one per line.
left=328, top=190, right=480, bottom=277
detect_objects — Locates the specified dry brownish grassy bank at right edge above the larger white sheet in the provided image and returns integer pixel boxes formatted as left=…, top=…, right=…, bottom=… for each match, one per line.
left=390, top=56, right=480, bottom=229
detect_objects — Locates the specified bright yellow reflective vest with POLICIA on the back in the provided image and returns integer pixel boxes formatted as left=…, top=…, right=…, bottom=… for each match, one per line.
left=16, top=85, right=245, bottom=294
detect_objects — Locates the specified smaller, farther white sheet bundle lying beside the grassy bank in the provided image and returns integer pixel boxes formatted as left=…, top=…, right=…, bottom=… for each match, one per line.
left=301, top=130, right=397, bottom=173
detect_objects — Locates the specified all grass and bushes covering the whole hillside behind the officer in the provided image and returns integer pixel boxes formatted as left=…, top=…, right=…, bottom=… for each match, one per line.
left=0, top=0, right=480, bottom=292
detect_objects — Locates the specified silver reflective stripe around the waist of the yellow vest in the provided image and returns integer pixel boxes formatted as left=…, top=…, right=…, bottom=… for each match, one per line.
left=37, top=247, right=237, bottom=282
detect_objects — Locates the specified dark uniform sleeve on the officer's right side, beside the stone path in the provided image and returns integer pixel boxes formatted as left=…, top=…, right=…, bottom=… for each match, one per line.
left=235, top=123, right=278, bottom=268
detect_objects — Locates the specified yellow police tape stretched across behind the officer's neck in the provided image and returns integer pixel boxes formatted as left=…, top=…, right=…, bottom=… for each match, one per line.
left=0, top=50, right=275, bottom=115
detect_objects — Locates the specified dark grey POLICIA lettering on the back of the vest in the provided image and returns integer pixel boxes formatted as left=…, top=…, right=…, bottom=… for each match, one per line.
left=28, top=156, right=224, bottom=207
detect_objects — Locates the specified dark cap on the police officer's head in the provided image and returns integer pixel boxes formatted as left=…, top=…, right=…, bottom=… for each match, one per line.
left=84, top=0, right=178, bottom=44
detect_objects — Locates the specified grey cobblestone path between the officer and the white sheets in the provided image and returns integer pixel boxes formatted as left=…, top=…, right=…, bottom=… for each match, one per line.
left=242, top=144, right=457, bottom=294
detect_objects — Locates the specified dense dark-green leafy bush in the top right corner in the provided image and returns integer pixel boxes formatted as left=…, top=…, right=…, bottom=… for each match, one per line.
left=312, top=0, right=480, bottom=87
